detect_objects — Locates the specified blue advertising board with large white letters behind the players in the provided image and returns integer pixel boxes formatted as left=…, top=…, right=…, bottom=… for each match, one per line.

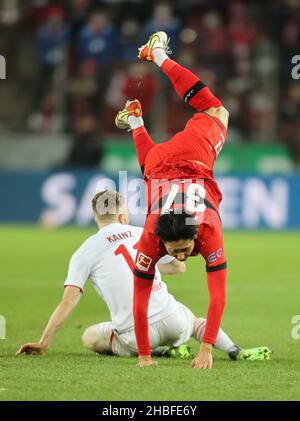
left=0, top=171, right=300, bottom=229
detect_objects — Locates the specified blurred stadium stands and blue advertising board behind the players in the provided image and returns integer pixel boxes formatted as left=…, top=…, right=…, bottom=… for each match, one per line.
left=0, top=0, right=300, bottom=229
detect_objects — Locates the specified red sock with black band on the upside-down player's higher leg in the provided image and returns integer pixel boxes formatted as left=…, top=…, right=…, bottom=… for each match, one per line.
left=161, top=58, right=222, bottom=111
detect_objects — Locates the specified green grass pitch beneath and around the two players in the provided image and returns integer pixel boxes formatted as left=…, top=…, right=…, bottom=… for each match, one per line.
left=0, top=226, right=300, bottom=401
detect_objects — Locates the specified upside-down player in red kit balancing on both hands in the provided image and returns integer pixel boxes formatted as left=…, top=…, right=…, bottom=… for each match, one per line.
left=116, top=32, right=229, bottom=368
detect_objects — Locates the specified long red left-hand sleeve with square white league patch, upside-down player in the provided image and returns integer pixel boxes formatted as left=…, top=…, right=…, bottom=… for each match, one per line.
left=133, top=229, right=165, bottom=355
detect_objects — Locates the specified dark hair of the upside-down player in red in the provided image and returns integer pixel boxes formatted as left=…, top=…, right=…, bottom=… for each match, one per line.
left=155, top=211, right=198, bottom=243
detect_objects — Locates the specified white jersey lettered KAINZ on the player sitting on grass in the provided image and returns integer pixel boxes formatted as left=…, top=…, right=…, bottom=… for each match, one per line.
left=65, top=223, right=177, bottom=333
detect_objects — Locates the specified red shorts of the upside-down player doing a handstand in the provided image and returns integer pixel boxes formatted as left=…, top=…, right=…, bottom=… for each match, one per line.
left=144, top=112, right=227, bottom=178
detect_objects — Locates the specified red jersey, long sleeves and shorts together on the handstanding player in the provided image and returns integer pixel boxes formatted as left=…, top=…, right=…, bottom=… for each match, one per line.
left=134, top=113, right=226, bottom=355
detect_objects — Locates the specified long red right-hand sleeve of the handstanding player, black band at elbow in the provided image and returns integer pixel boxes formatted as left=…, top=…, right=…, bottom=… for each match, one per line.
left=200, top=210, right=227, bottom=344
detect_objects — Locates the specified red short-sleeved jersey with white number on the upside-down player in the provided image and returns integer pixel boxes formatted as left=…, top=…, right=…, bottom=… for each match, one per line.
left=136, top=170, right=226, bottom=275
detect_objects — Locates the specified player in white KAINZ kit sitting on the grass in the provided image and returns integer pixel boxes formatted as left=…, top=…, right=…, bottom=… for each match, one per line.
left=17, top=190, right=270, bottom=360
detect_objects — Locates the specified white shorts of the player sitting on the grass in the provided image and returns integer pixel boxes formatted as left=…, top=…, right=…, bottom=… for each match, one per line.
left=97, top=303, right=194, bottom=357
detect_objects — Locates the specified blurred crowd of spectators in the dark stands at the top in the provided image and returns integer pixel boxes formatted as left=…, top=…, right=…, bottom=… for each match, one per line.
left=0, top=0, right=300, bottom=164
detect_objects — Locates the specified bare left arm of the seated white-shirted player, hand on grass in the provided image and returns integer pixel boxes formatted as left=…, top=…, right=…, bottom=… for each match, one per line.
left=17, top=286, right=82, bottom=355
